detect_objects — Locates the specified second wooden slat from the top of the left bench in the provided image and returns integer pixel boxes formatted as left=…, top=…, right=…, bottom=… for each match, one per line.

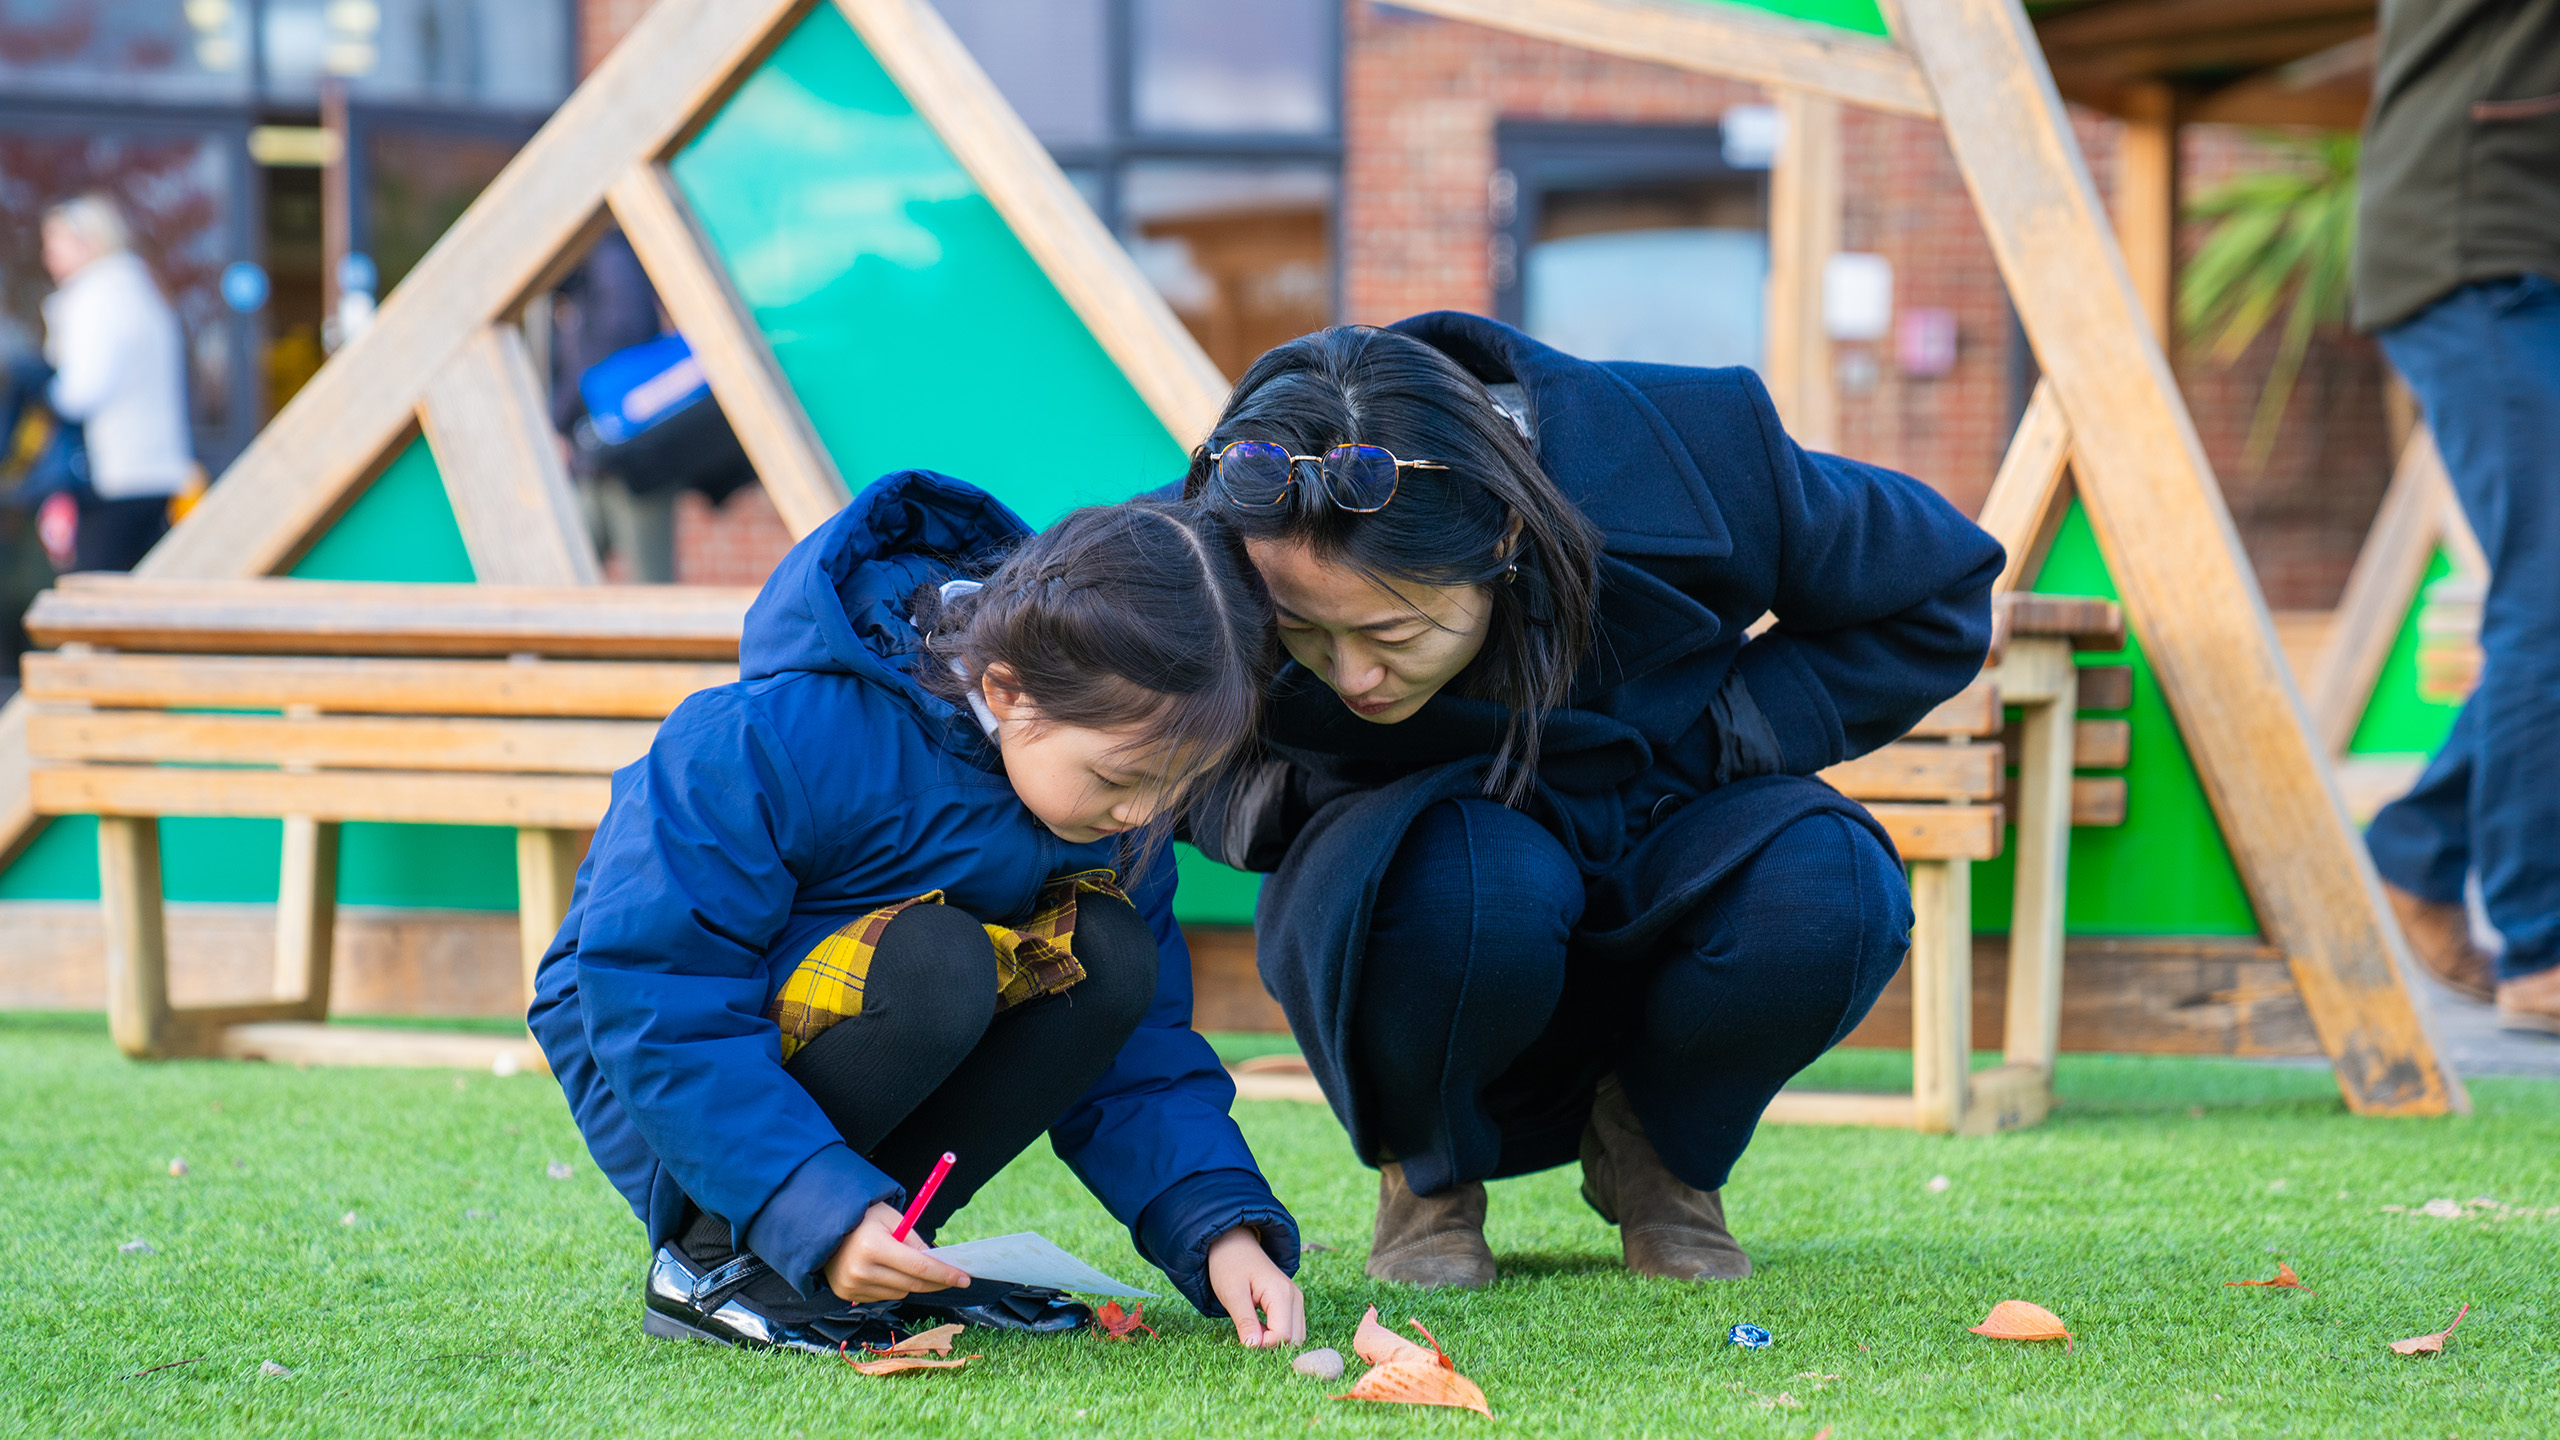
left=20, top=653, right=737, bottom=720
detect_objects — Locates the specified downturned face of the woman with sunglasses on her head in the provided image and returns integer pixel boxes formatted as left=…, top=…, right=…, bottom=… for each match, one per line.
left=1244, top=541, right=1492, bottom=725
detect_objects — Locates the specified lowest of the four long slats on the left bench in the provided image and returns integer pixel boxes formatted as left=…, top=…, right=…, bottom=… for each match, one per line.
left=28, top=766, right=612, bottom=830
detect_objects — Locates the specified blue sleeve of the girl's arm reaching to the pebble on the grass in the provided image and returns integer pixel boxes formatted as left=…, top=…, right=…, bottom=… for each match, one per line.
left=1050, top=848, right=1298, bottom=1314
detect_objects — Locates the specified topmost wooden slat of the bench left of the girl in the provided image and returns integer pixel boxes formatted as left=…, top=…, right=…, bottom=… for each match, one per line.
left=26, top=577, right=755, bottom=661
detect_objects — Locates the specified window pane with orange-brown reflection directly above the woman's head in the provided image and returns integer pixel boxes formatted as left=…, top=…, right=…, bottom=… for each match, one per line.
left=1121, top=161, right=1336, bottom=377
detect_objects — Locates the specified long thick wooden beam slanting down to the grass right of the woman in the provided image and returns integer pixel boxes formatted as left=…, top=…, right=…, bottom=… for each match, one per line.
left=1894, top=0, right=2468, bottom=1115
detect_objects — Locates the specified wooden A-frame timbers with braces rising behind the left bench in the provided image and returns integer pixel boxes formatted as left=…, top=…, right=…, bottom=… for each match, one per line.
left=0, top=0, right=1226, bottom=887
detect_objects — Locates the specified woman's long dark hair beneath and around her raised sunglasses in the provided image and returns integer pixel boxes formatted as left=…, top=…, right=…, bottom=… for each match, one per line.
left=1183, top=325, right=1600, bottom=805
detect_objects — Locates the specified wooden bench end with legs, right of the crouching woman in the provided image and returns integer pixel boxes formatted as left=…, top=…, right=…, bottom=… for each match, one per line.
left=1766, top=594, right=2132, bottom=1135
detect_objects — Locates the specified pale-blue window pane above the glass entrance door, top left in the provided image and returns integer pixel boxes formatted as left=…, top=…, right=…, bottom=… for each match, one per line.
left=258, top=0, right=571, bottom=110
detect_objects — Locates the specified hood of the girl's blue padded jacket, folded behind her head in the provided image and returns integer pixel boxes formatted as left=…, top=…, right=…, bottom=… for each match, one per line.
left=737, top=469, right=1032, bottom=730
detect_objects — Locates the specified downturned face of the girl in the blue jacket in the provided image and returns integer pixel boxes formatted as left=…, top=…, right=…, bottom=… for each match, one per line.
left=980, top=666, right=1193, bottom=846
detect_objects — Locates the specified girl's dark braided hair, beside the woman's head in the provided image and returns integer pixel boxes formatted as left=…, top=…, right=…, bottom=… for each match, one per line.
left=914, top=500, right=1275, bottom=814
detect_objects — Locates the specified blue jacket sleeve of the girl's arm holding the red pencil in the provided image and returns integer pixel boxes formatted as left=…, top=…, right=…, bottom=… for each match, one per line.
left=576, top=689, right=904, bottom=1294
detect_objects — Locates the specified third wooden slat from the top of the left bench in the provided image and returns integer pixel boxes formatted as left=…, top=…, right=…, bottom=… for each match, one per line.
left=26, top=710, right=658, bottom=774
